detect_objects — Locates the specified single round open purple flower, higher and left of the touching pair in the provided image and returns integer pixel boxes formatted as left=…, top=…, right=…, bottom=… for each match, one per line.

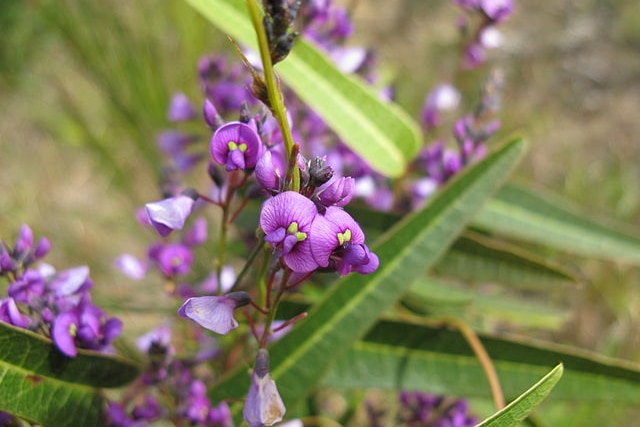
left=210, top=122, right=262, bottom=171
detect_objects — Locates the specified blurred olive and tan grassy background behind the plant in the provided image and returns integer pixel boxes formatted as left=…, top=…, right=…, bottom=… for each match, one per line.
left=0, top=0, right=640, bottom=426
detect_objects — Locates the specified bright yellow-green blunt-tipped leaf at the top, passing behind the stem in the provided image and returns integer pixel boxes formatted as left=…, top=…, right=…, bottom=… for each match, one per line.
left=186, top=0, right=421, bottom=177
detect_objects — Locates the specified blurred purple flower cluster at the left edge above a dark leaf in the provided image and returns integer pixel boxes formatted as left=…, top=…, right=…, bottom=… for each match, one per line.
left=0, top=225, right=122, bottom=357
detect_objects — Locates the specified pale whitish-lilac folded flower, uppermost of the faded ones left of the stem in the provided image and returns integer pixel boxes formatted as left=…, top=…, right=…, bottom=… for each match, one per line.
left=145, top=190, right=198, bottom=237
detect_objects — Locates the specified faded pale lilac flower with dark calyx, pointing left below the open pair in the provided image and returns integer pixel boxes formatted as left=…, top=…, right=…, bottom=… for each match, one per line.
left=178, top=292, right=251, bottom=335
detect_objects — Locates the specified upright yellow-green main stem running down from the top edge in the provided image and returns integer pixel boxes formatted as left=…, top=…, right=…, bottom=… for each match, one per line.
left=247, top=0, right=300, bottom=191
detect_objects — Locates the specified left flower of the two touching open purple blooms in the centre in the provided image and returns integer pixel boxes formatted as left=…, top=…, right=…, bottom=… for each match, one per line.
left=260, top=191, right=318, bottom=273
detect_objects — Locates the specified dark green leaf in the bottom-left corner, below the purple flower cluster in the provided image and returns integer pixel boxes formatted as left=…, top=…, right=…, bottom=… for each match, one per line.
left=0, top=322, right=137, bottom=426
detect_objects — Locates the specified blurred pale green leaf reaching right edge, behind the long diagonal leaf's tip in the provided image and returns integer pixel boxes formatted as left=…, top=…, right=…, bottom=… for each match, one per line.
left=474, top=185, right=640, bottom=264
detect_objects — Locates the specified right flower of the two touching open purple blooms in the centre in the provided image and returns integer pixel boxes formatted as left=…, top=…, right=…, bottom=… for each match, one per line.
left=310, top=206, right=379, bottom=275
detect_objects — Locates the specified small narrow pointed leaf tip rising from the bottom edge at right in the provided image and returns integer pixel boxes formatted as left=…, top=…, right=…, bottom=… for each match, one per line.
left=477, top=364, right=562, bottom=427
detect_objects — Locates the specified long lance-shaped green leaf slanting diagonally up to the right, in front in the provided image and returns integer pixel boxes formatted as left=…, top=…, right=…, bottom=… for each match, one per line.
left=213, top=140, right=524, bottom=414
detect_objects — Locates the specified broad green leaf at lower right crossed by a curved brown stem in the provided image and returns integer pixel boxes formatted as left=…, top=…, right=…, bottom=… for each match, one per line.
left=322, top=321, right=640, bottom=405
